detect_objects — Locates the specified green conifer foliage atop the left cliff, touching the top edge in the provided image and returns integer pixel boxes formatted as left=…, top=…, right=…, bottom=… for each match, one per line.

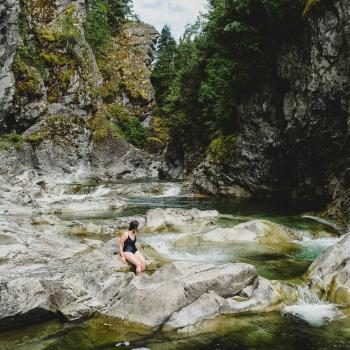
left=84, top=0, right=130, bottom=58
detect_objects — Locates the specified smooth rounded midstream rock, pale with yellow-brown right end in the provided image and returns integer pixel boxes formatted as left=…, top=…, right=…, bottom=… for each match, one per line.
left=202, top=220, right=292, bottom=244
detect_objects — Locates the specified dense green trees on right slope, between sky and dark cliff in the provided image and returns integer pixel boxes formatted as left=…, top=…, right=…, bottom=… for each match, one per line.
left=153, top=0, right=304, bottom=163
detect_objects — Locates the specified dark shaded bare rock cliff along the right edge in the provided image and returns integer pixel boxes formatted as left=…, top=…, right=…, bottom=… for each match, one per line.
left=194, top=0, right=350, bottom=216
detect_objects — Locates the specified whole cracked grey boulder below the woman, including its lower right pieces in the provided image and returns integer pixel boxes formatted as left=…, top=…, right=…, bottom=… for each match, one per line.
left=108, top=262, right=281, bottom=328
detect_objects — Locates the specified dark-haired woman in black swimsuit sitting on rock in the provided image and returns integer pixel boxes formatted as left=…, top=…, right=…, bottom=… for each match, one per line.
left=119, top=221, right=146, bottom=274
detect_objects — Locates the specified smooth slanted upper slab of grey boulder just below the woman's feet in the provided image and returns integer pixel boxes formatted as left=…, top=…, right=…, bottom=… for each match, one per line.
left=108, top=261, right=258, bottom=327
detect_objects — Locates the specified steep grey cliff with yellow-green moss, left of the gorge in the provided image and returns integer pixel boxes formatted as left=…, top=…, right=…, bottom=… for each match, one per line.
left=0, top=0, right=158, bottom=178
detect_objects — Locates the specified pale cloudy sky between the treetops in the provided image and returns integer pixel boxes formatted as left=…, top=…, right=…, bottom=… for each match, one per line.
left=133, top=0, right=206, bottom=39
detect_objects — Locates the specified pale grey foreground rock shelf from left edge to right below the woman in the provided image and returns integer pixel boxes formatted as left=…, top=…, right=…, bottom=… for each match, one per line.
left=0, top=215, right=282, bottom=329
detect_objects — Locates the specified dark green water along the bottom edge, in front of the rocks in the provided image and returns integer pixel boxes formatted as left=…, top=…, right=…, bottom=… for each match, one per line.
left=0, top=310, right=350, bottom=350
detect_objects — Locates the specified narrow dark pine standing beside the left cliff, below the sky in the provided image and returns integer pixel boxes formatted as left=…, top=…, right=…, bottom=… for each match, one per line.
left=151, top=25, right=177, bottom=107
